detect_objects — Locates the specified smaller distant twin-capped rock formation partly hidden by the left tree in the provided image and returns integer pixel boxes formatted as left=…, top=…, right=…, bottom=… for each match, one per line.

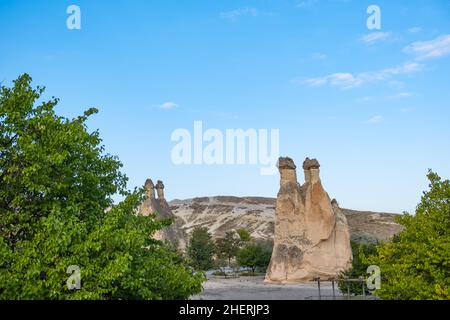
left=138, top=179, right=186, bottom=250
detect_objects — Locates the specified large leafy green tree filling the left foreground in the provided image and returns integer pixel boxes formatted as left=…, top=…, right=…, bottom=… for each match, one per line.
left=0, top=74, right=204, bottom=299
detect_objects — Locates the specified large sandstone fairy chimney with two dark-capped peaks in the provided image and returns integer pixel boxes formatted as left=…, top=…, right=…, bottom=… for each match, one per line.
left=266, top=158, right=352, bottom=283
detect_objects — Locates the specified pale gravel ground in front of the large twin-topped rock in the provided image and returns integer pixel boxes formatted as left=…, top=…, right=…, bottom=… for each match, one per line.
left=192, top=277, right=342, bottom=300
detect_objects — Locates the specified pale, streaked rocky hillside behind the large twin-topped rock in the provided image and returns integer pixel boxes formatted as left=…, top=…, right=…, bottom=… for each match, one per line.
left=169, top=196, right=401, bottom=242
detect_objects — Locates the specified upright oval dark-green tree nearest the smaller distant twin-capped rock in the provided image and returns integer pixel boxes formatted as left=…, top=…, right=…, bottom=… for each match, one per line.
left=187, top=227, right=215, bottom=271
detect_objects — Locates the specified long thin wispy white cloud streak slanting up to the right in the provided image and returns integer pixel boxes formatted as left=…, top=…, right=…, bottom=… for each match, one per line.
left=296, top=62, right=422, bottom=89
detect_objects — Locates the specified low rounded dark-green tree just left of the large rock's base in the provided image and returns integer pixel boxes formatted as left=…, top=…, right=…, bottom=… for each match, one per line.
left=236, top=244, right=272, bottom=273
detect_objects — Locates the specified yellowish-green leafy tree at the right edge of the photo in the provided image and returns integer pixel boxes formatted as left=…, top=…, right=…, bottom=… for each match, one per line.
left=367, top=170, right=450, bottom=300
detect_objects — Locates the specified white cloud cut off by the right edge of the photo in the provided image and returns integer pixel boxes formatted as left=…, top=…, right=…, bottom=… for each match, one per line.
left=403, top=34, right=450, bottom=61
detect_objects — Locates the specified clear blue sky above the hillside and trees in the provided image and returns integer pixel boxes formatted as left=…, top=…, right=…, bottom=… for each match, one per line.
left=0, top=0, right=450, bottom=212
